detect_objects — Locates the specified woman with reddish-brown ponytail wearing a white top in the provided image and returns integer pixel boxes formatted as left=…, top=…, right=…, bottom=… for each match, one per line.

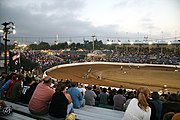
left=122, top=87, right=151, bottom=120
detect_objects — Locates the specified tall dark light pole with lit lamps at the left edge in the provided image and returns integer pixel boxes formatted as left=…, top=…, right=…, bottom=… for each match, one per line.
left=1, top=22, right=16, bottom=73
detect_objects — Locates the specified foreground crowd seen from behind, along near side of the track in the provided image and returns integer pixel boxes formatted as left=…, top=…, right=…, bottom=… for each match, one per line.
left=0, top=72, right=180, bottom=120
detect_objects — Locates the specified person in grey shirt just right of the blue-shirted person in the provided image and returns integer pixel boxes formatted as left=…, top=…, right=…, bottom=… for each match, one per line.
left=85, top=85, right=97, bottom=106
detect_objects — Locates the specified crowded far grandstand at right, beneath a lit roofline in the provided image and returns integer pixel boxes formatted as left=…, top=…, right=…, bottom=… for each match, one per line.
left=110, top=42, right=180, bottom=65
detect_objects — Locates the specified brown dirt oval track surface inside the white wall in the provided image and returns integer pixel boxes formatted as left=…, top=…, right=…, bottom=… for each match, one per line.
left=47, top=64, right=180, bottom=92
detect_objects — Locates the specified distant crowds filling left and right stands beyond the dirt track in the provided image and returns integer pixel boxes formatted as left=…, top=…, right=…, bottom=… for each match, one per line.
left=10, top=47, right=180, bottom=72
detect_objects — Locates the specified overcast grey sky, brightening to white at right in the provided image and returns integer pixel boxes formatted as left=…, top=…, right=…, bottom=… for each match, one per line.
left=0, top=0, right=180, bottom=42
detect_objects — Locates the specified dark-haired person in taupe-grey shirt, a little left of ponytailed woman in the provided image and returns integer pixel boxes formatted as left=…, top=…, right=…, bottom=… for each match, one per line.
left=113, top=89, right=126, bottom=111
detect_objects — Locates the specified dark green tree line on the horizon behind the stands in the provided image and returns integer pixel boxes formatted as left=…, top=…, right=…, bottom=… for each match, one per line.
left=0, top=40, right=115, bottom=51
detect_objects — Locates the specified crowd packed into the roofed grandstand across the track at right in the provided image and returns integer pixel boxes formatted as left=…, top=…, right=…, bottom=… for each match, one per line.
left=110, top=47, right=180, bottom=65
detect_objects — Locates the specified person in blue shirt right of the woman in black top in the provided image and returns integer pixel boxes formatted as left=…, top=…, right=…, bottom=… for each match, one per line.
left=67, top=83, right=85, bottom=108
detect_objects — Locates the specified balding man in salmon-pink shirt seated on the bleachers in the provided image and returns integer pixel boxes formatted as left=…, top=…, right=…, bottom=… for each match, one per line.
left=28, top=76, right=55, bottom=115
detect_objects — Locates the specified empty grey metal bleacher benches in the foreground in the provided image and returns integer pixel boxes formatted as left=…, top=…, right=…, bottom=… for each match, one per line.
left=0, top=101, right=124, bottom=120
